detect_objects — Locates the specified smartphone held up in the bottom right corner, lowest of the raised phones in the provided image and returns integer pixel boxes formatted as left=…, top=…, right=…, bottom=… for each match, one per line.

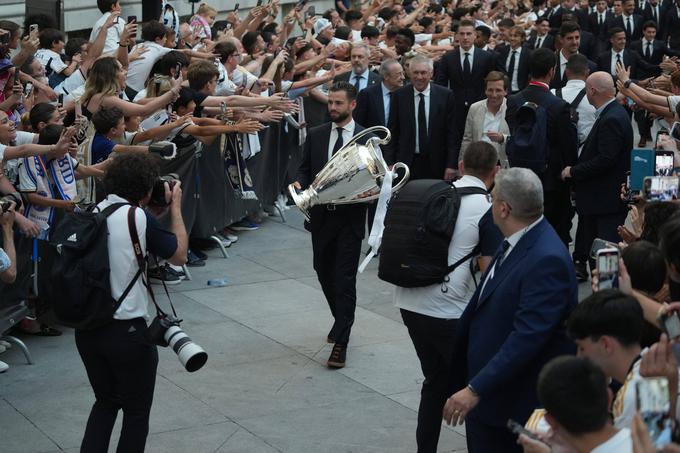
left=635, top=378, right=673, bottom=450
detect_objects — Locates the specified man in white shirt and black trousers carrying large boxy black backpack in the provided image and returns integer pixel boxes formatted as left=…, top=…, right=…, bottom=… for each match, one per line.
left=394, top=141, right=502, bottom=453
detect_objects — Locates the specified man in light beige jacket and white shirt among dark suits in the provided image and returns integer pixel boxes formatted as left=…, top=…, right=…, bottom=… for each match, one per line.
left=458, top=71, right=510, bottom=168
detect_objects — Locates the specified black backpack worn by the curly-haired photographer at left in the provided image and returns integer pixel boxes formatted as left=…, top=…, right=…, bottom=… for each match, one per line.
left=48, top=203, right=144, bottom=330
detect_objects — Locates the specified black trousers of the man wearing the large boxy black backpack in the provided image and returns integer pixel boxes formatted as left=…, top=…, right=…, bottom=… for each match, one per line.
left=401, top=309, right=458, bottom=453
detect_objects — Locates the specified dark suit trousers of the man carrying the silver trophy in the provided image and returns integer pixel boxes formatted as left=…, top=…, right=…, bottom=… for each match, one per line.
left=312, top=225, right=361, bottom=346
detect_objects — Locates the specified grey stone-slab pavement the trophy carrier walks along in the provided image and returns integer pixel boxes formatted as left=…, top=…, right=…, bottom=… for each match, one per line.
left=0, top=209, right=472, bottom=453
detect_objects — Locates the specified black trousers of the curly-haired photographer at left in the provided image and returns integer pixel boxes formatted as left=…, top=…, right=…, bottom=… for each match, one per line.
left=76, top=318, right=158, bottom=453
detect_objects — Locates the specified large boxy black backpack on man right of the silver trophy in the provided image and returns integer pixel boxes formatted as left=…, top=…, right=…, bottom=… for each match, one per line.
left=378, top=179, right=488, bottom=288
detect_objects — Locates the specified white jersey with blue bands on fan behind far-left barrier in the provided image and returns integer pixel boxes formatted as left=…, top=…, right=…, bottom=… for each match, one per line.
left=23, top=154, right=78, bottom=239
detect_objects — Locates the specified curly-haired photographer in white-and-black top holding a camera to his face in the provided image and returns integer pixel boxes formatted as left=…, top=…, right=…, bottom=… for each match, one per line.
left=75, top=153, right=188, bottom=453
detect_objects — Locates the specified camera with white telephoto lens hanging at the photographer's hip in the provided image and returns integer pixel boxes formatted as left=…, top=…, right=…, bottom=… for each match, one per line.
left=145, top=313, right=208, bottom=373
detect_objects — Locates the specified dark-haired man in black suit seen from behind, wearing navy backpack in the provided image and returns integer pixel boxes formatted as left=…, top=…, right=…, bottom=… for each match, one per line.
left=506, top=49, right=578, bottom=244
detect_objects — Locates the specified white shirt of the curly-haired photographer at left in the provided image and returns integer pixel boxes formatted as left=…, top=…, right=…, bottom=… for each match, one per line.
left=97, top=195, right=149, bottom=319
